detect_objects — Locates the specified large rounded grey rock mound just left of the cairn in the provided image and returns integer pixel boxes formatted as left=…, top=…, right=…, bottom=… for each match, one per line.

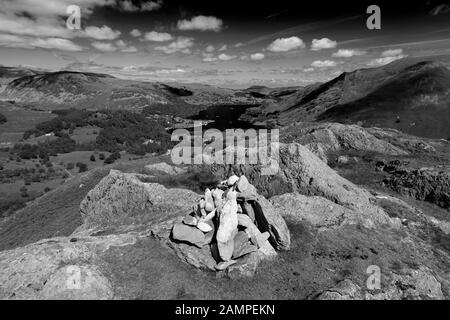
left=80, top=170, right=198, bottom=230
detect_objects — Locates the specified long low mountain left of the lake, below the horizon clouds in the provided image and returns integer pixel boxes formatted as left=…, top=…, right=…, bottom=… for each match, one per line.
left=0, top=71, right=262, bottom=112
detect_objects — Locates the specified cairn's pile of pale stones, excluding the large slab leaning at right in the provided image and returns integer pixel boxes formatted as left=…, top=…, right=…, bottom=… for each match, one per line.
left=172, top=175, right=274, bottom=270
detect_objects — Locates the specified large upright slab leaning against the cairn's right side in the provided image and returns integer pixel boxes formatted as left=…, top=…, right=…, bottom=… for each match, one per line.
left=253, top=196, right=291, bottom=250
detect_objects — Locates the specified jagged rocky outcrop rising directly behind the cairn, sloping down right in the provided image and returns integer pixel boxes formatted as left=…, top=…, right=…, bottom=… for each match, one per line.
left=204, top=143, right=398, bottom=227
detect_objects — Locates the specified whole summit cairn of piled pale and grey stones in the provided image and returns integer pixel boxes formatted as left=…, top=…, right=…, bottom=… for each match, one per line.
left=171, top=175, right=290, bottom=275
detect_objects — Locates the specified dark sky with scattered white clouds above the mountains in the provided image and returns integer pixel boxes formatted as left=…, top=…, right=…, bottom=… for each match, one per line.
left=0, top=0, right=450, bottom=88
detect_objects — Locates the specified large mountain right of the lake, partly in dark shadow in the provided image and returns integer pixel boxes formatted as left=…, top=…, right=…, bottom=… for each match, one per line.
left=243, top=59, right=450, bottom=138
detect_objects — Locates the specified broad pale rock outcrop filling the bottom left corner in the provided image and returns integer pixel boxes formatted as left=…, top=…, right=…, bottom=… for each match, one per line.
left=0, top=234, right=139, bottom=300
